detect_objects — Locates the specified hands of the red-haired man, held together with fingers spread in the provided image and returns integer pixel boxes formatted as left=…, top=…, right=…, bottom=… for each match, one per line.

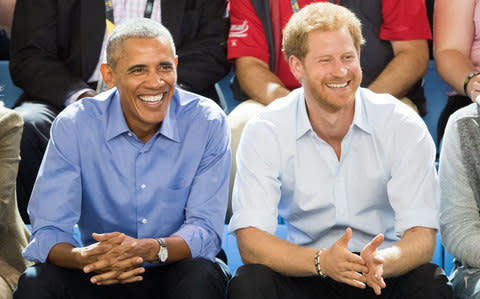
left=321, top=228, right=386, bottom=295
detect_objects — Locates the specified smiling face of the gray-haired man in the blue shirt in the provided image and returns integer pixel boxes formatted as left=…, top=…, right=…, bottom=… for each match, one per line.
left=101, top=38, right=178, bottom=142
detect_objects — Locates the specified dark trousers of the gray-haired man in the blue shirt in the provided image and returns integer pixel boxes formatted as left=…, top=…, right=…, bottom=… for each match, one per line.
left=13, top=258, right=229, bottom=299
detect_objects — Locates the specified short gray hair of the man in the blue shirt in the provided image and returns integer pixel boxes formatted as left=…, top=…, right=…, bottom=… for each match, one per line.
left=107, top=18, right=176, bottom=67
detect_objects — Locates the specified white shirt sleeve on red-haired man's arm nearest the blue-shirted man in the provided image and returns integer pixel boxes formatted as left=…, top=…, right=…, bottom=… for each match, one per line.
left=229, top=120, right=281, bottom=234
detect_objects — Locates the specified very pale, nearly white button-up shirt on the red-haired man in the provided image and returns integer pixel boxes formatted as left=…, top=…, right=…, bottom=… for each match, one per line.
left=229, top=88, right=439, bottom=252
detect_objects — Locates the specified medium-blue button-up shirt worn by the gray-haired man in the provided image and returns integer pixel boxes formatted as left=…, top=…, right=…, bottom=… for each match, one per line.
left=23, top=89, right=231, bottom=262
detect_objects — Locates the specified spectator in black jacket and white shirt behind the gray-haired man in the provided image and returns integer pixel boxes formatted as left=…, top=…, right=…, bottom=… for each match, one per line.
left=10, top=0, right=230, bottom=223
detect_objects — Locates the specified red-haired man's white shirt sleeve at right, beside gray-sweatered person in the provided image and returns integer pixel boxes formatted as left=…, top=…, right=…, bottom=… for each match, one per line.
left=387, top=112, right=440, bottom=237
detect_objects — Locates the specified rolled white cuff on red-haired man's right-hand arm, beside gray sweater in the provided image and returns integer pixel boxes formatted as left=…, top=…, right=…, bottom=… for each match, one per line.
left=395, top=208, right=440, bottom=238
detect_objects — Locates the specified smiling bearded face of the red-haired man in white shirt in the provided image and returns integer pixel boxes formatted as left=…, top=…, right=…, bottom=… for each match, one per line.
left=289, top=27, right=362, bottom=112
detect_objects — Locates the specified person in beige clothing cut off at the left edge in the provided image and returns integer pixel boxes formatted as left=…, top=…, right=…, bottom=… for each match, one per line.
left=0, top=101, right=30, bottom=299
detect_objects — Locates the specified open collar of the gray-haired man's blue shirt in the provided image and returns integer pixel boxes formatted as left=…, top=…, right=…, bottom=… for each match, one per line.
left=105, top=88, right=180, bottom=142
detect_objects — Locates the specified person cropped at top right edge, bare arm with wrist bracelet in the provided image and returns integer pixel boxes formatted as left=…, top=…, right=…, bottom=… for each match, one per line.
left=433, top=0, right=480, bottom=143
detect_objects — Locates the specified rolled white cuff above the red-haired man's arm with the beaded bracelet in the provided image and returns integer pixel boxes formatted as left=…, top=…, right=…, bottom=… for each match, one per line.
left=228, top=210, right=278, bottom=235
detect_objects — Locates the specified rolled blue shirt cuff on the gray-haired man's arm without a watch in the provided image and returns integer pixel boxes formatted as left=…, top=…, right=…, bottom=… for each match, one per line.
left=22, top=228, right=80, bottom=263
